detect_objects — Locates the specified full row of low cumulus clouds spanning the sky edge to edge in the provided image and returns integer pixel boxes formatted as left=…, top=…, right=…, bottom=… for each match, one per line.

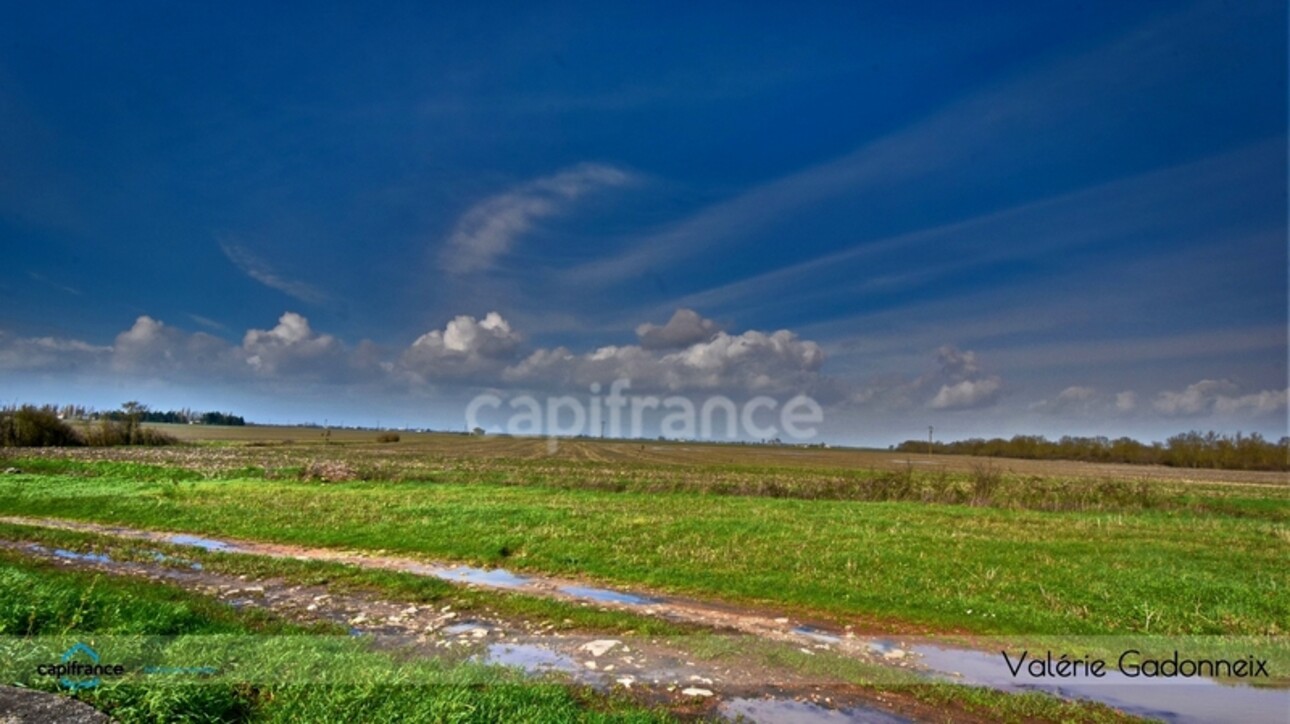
left=0, top=310, right=1290, bottom=433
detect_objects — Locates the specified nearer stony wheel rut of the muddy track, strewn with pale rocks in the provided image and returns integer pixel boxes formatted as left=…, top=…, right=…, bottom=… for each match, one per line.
left=0, top=518, right=949, bottom=724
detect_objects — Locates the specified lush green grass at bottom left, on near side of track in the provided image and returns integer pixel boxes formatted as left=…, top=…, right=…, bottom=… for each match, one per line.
left=0, top=551, right=668, bottom=723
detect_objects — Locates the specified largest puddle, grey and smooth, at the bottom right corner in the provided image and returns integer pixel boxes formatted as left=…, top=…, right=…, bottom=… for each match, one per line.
left=913, top=645, right=1290, bottom=724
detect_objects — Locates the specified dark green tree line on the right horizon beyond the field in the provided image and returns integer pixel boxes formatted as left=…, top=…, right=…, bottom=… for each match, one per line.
left=893, top=430, right=1290, bottom=470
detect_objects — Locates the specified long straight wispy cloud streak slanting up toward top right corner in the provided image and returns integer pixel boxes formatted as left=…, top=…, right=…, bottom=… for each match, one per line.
left=565, top=4, right=1267, bottom=286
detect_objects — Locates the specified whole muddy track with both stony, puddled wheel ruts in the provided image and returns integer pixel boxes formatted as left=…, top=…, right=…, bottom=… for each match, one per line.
left=0, top=516, right=1290, bottom=724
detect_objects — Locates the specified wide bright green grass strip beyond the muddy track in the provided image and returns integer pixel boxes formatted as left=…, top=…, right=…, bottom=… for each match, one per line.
left=0, top=431, right=1290, bottom=635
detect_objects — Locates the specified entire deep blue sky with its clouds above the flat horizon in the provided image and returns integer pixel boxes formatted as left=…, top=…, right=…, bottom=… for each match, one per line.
left=0, top=1, right=1287, bottom=445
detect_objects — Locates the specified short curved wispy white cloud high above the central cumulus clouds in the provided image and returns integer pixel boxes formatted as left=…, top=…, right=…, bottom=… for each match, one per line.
left=441, top=164, right=632, bottom=274
